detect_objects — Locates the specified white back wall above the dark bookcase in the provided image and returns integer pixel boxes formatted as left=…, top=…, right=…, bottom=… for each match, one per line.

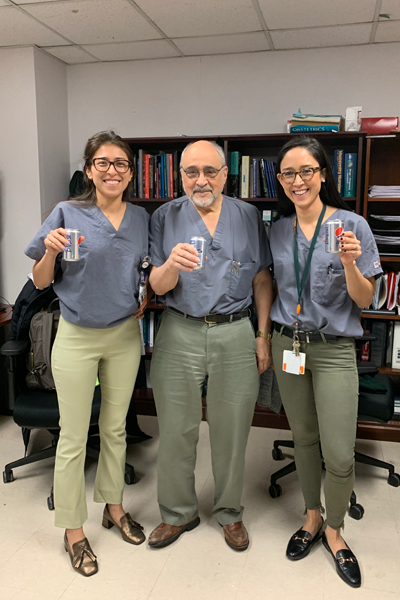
left=68, top=43, right=400, bottom=172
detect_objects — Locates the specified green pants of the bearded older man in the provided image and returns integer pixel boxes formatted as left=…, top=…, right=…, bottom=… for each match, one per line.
left=150, top=309, right=258, bottom=525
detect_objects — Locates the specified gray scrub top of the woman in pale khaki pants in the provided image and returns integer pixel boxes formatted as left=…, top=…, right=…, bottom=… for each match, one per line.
left=25, top=201, right=149, bottom=329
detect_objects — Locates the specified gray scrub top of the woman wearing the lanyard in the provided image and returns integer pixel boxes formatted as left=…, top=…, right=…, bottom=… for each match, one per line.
left=270, top=208, right=382, bottom=337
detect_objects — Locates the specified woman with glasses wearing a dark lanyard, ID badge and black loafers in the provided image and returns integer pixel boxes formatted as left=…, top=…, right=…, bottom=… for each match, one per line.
left=270, top=137, right=382, bottom=587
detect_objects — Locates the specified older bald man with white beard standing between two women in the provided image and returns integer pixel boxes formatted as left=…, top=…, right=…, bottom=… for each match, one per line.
left=149, top=140, right=272, bottom=550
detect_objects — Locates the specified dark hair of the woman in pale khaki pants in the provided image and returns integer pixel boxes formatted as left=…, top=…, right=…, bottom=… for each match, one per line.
left=68, top=131, right=135, bottom=206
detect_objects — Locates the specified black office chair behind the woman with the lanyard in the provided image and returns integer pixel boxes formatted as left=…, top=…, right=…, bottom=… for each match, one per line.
left=269, top=335, right=400, bottom=520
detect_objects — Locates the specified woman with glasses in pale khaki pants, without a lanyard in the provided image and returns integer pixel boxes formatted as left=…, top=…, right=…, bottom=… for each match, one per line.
left=25, top=131, right=149, bottom=576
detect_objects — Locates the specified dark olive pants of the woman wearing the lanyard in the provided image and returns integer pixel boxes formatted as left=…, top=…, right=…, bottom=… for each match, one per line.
left=272, top=331, right=358, bottom=529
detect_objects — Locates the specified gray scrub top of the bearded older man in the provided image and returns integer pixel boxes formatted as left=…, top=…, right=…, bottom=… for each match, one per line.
left=150, top=196, right=272, bottom=317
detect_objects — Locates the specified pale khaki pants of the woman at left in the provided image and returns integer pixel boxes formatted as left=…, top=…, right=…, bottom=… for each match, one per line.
left=52, top=317, right=141, bottom=529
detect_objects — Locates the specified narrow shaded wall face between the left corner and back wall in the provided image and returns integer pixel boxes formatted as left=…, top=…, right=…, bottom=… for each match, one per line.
left=34, top=49, right=70, bottom=220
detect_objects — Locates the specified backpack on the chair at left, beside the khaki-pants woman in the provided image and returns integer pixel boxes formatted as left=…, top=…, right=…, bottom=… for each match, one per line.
left=26, top=298, right=60, bottom=390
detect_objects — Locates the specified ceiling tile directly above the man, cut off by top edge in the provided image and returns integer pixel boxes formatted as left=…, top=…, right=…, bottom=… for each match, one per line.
left=135, top=0, right=261, bottom=37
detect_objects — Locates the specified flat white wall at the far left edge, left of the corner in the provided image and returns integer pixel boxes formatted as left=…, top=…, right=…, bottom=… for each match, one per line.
left=0, top=48, right=41, bottom=303
